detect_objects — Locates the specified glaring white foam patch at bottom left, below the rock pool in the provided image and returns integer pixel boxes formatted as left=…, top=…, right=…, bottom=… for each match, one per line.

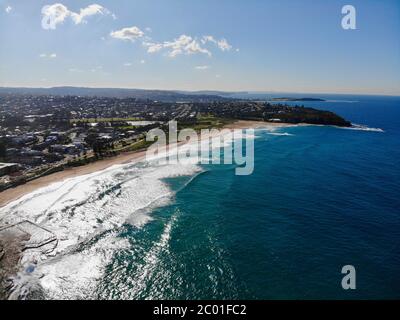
left=10, top=234, right=129, bottom=299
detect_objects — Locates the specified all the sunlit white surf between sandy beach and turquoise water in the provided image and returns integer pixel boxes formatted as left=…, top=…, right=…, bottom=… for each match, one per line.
left=0, top=162, right=201, bottom=299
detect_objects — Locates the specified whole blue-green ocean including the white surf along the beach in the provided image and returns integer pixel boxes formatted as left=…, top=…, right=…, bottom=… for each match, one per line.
left=0, top=95, right=400, bottom=299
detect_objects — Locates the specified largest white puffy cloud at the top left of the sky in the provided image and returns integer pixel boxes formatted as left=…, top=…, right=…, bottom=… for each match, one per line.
left=42, top=3, right=116, bottom=30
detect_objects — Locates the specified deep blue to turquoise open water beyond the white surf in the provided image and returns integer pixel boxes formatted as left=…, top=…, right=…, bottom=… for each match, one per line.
left=97, top=96, right=400, bottom=299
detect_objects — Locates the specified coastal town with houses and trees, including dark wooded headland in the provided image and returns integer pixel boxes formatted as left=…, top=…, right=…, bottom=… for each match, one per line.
left=0, top=93, right=349, bottom=191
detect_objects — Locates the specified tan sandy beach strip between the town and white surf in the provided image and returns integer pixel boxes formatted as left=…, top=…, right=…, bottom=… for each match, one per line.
left=0, top=120, right=293, bottom=208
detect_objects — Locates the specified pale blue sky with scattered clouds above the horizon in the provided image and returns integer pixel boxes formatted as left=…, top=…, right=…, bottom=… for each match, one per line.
left=0, top=0, right=400, bottom=95
